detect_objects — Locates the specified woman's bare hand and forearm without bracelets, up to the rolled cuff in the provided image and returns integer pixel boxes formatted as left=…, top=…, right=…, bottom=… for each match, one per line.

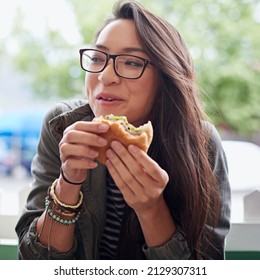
left=107, top=141, right=176, bottom=247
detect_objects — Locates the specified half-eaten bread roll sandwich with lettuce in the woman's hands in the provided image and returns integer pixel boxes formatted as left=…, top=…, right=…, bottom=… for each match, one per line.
left=93, top=114, right=153, bottom=164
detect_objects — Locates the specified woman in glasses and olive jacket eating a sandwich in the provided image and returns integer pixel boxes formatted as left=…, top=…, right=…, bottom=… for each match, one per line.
left=16, top=1, right=230, bottom=259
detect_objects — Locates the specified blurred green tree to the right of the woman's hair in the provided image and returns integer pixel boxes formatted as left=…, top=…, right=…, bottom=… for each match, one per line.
left=152, top=0, right=260, bottom=134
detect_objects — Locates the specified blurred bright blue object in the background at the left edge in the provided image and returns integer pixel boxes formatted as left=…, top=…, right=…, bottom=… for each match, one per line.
left=0, top=110, right=45, bottom=175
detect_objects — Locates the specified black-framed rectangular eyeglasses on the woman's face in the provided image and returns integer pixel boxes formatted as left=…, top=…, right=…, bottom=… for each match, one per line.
left=79, top=49, right=153, bottom=79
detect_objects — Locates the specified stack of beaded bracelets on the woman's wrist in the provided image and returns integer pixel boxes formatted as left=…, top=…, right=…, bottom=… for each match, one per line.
left=45, top=180, right=83, bottom=226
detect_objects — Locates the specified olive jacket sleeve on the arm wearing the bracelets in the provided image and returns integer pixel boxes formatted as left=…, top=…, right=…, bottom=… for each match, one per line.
left=16, top=103, right=79, bottom=259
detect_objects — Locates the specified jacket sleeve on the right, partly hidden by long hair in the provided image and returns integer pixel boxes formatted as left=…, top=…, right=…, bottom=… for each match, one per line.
left=143, top=124, right=231, bottom=260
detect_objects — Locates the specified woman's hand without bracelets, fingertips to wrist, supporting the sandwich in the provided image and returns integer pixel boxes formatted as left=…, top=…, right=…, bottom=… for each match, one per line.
left=107, top=141, right=169, bottom=214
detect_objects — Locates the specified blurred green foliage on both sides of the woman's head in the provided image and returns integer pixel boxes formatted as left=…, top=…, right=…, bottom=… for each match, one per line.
left=5, top=0, right=260, bottom=134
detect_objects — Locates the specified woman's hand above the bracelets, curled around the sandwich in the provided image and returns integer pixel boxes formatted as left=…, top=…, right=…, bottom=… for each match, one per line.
left=59, top=121, right=108, bottom=182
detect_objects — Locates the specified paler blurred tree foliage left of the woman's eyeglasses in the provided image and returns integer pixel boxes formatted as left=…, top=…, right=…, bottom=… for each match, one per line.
left=8, top=6, right=84, bottom=98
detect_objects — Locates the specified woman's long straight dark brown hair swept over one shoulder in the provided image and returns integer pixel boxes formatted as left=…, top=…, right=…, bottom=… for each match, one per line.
left=97, top=1, right=219, bottom=259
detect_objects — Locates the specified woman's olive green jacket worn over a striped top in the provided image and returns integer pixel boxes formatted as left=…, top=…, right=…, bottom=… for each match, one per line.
left=16, top=100, right=230, bottom=259
